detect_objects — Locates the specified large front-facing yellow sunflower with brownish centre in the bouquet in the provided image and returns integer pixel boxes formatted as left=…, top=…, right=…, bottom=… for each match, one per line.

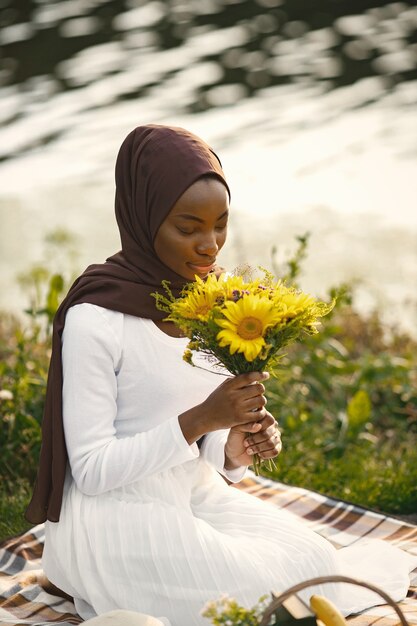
left=215, top=294, right=279, bottom=361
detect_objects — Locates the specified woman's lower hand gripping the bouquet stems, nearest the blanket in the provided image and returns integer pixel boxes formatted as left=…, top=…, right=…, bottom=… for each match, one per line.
left=225, top=411, right=282, bottom=469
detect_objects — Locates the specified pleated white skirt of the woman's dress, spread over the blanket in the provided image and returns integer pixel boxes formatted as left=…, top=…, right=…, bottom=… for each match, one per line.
left=46, top=458, right=417, bottom=626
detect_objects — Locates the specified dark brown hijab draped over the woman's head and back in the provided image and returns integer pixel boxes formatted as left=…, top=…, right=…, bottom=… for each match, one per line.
left=25, top=125, right=230, bottom=524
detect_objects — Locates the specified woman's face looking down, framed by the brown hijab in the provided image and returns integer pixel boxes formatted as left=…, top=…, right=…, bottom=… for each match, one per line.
left=154, top=177, right=229, bottom=280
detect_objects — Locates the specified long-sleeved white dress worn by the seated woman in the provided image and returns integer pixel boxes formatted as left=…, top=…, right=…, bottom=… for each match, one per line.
left=43, top=304, right=417, bottom=626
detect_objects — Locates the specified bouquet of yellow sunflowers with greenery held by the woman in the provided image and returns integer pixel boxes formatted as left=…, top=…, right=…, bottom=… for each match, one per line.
left=153, top=270, right=334, bottom=473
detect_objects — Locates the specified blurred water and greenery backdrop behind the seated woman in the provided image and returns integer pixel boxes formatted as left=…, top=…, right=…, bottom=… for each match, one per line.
left=0, top=0, right=417, bottom=537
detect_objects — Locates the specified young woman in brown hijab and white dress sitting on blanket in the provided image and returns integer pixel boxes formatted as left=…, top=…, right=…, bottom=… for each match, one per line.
left=27, top=125, right=417, bottom=626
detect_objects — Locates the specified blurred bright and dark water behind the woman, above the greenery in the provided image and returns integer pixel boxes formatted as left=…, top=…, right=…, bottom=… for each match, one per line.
left=0, top=0, right=417, bottom=333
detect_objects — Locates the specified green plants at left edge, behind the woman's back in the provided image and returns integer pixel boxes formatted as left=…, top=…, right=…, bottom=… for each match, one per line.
left=0, top=231, right=75, bottom=494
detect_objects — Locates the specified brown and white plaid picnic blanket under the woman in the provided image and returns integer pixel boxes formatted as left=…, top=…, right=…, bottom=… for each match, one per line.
left=0, top=473, right=417, bottom=626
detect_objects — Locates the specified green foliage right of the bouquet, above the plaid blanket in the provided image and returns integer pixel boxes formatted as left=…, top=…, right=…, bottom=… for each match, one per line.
left=266, top=305, right=417, bottom=514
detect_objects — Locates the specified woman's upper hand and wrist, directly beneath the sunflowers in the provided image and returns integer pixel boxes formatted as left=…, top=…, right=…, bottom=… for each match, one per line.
left=179, top=372, right=269, bottom=444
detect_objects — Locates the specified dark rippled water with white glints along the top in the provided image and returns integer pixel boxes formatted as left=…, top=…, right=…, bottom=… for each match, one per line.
left=0, top=0, right=417, bottom=159
